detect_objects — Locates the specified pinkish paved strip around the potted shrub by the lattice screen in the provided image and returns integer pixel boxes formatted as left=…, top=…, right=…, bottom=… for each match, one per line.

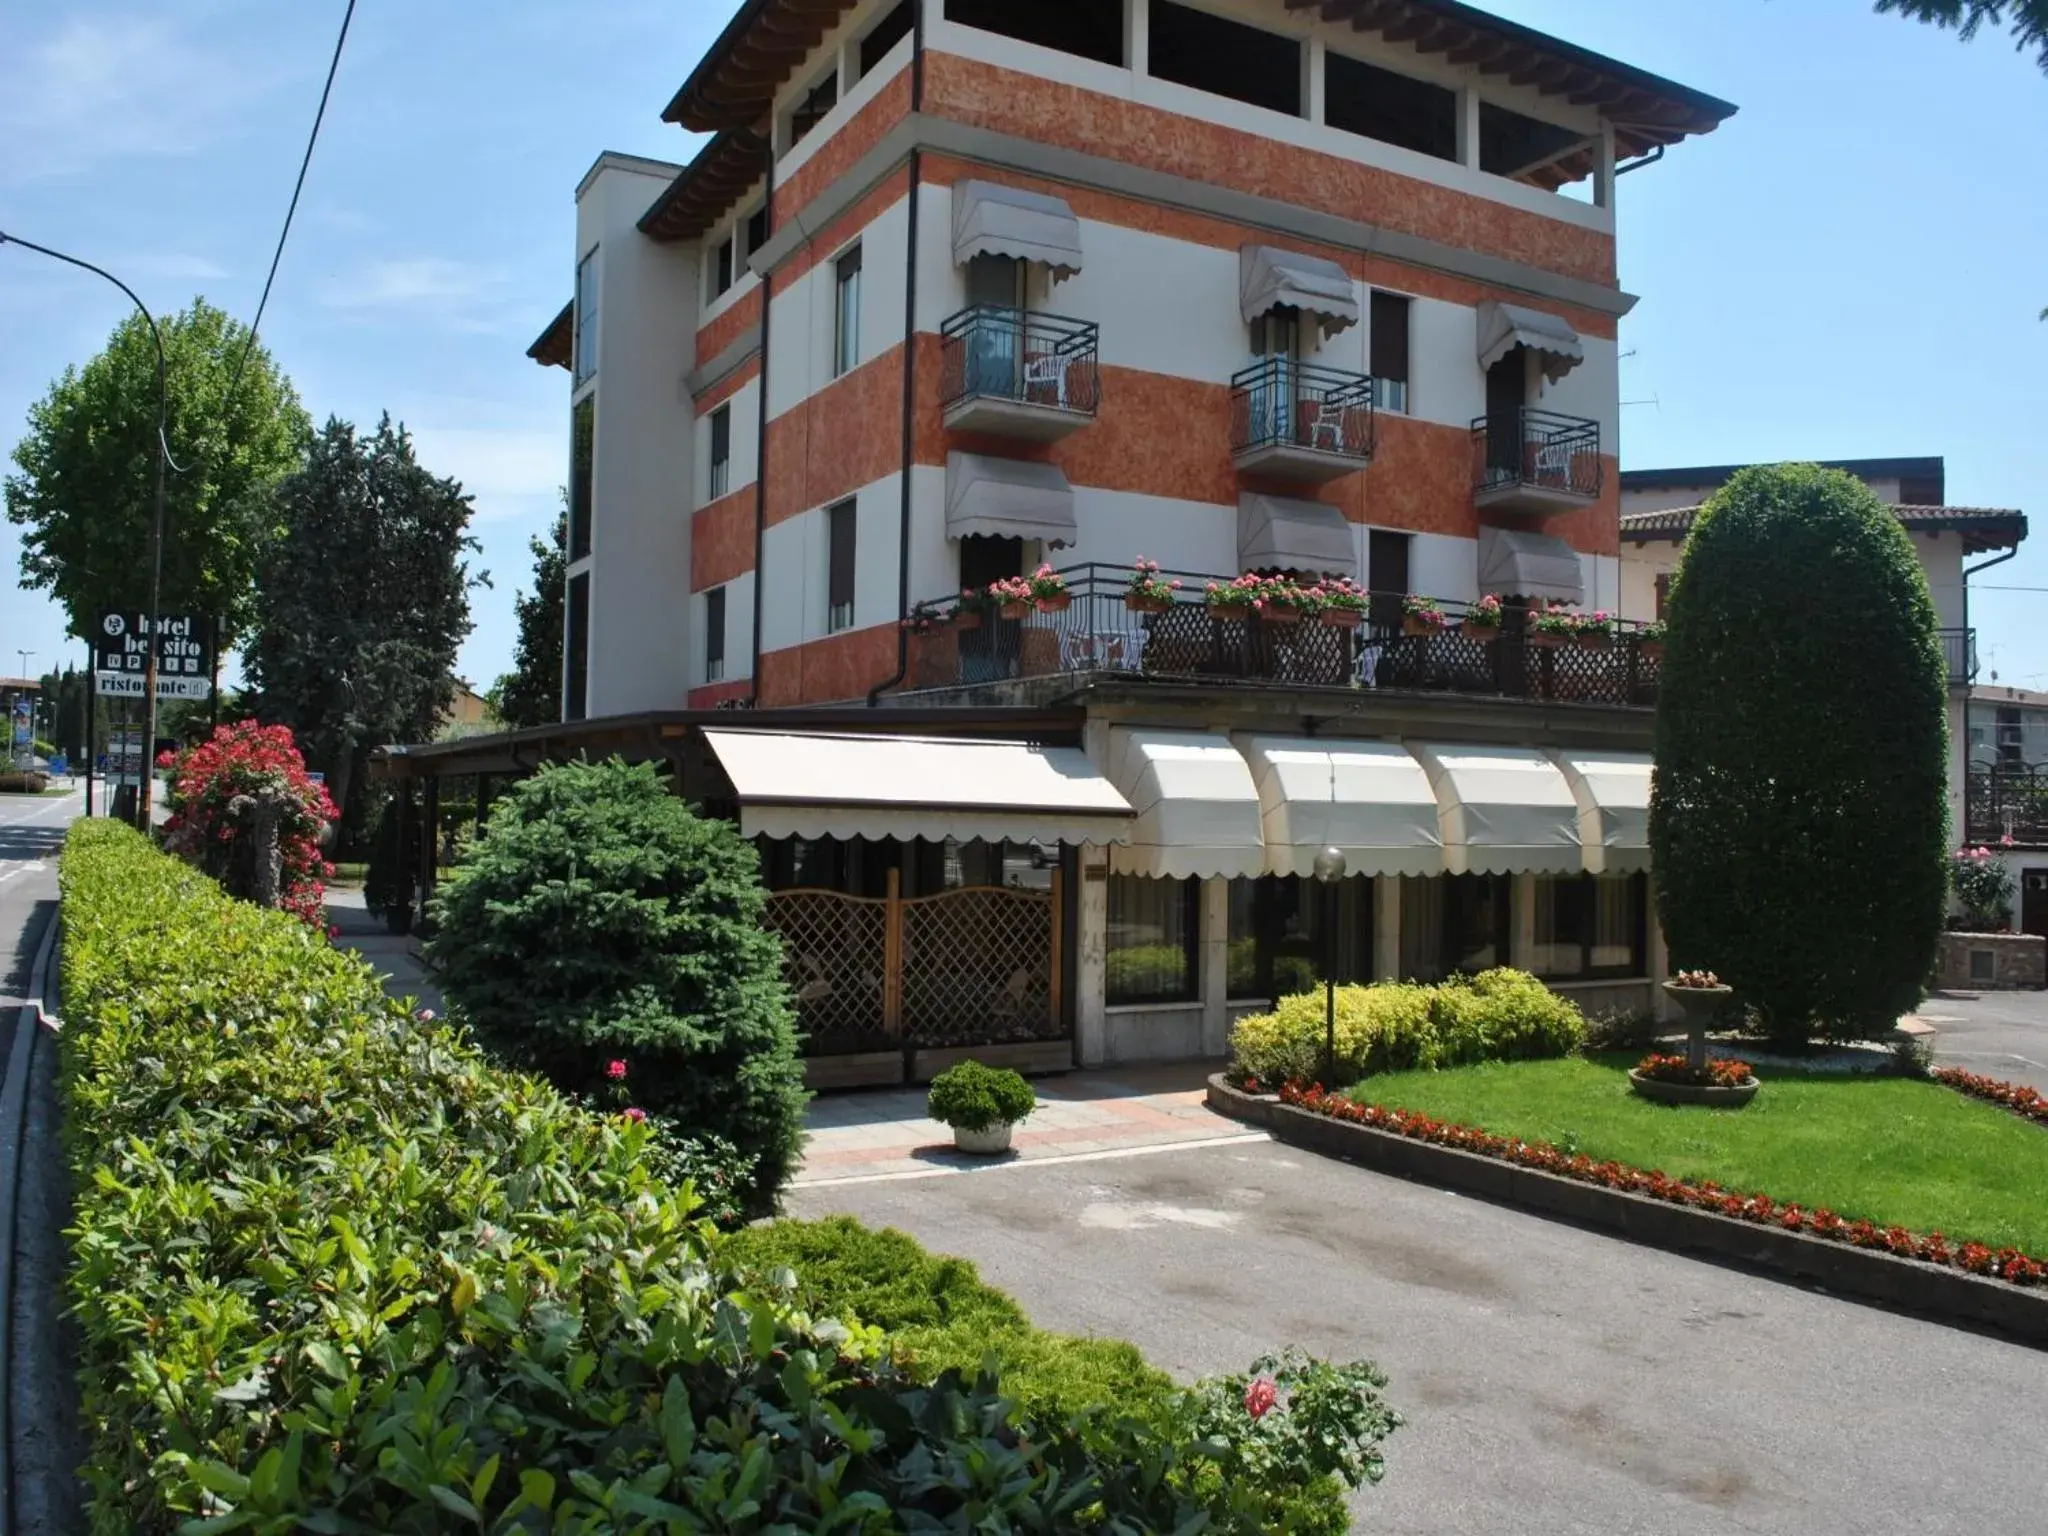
left=797, top=1063, right=1266, bottom=1186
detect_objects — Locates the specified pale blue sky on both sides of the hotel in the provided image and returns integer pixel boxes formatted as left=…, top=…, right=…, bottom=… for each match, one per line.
left=0, top=0, right=2048, bottom=688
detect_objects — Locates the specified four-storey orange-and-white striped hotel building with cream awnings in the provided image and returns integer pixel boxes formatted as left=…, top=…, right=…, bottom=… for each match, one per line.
left=483, top=0, right=1735, bottom=1081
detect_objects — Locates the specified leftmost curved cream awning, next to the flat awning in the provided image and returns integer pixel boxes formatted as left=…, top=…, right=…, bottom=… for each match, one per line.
left=1104, top=725, right=1266, bottom=879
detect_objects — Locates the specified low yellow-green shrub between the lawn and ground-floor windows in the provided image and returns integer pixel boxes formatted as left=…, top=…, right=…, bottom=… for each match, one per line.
left=1231, top=967, right=1585, bottom=1087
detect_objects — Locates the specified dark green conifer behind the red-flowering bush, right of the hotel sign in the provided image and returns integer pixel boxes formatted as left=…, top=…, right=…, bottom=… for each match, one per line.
left=246, top=416, right=483, bottom=840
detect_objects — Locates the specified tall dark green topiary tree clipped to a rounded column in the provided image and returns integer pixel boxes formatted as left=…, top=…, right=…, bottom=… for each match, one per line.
left=1651, top=465, right=1948, bottom=1047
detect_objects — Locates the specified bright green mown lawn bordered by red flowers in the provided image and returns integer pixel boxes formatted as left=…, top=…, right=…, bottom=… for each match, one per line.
left=1352, top=1055, right=2048, bottom=1255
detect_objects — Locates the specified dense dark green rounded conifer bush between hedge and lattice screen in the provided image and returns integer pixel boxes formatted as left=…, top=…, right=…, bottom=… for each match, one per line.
left=426, top=762, right=807, bottom=1214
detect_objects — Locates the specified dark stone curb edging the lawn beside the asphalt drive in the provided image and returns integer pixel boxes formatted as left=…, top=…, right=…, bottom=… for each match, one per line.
left=1208, top=1075, right=2048, bottom=1350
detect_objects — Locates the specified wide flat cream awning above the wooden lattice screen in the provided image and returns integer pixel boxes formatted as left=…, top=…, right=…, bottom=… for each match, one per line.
left=705, top=729, right=1130, bottom=844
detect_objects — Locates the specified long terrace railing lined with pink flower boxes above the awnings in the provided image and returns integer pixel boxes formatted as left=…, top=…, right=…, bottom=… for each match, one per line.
left=907, top=565, right=1663, bottom=707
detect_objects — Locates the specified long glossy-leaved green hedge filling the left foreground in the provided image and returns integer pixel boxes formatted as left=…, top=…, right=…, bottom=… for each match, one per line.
left=59, top=835, right=1397, bottom=1536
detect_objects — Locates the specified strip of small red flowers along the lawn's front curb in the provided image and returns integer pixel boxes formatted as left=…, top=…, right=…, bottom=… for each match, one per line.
left=1280, top=1083, right=2048, bottom=1286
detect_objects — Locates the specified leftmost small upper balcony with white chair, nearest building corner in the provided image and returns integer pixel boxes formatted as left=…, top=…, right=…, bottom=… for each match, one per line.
left=938, top=305, right=1102, bottom=442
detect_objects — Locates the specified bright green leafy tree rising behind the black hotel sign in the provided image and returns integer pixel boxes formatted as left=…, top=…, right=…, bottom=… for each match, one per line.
left=6, top=299, right=309, bottom=641
